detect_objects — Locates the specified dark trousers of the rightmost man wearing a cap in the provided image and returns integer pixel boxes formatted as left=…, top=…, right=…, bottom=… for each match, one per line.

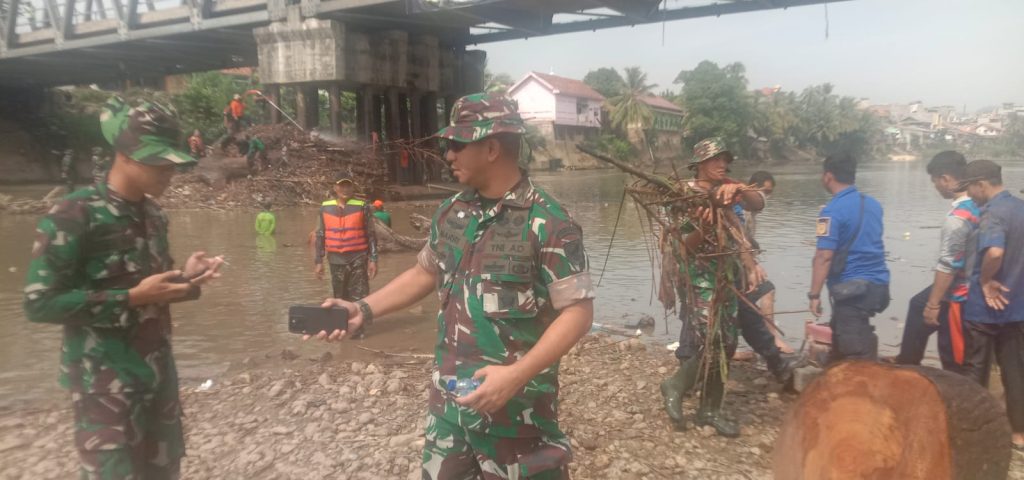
left=964, top=320, right=1024, bottom=433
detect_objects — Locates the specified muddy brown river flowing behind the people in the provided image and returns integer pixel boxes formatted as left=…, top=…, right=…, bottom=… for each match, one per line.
left=0, top=162, right=1024, bottom=405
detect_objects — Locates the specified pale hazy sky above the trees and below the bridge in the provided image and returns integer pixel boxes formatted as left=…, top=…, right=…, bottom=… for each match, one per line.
left=476, top=0, right=1024, bottom=112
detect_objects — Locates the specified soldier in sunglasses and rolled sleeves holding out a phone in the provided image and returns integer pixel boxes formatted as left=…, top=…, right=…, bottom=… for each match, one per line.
left=307, top=93, right=594, bottom=480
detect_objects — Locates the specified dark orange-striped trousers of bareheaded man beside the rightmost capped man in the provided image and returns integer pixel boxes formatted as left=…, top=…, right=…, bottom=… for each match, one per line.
left=896, top=286, right=963, bottom=374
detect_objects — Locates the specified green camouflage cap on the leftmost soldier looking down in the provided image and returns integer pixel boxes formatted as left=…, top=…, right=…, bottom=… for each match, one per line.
left=99, top=95, right=196, bottom=166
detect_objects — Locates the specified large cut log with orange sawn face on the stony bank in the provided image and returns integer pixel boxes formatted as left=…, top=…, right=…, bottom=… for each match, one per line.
left=774, top=361, right=1011, bottom=480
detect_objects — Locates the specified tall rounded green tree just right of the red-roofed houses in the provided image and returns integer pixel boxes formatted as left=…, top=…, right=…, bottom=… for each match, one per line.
left=675, top=60, right=754, bottom=151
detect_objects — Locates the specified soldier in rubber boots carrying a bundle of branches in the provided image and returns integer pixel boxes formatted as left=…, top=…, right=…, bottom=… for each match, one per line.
left=662, top=138, right=764, bottom=437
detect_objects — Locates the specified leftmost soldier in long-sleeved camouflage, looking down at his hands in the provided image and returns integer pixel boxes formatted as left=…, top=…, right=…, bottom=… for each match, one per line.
left=25, top=97, right=221, bottom=480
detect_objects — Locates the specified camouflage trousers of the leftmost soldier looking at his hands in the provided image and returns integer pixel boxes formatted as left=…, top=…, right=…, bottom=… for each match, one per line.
left=73, top=385, right=184, bottom=480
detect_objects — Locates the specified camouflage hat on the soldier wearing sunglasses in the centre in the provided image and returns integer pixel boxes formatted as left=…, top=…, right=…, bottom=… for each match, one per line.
left=433, top=92, right=526, bottom=143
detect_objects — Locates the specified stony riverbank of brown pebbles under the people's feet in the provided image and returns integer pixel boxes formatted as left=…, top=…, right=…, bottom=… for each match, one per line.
left=0, top=335, right=1024, bottom=480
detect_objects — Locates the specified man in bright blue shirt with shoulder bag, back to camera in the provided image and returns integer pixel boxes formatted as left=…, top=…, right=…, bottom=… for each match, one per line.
left=807, top=154, right=889, bottom=361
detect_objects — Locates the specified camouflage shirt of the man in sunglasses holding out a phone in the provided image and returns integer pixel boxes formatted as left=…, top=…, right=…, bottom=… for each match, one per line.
left=418, top=176, right=594, bottom=437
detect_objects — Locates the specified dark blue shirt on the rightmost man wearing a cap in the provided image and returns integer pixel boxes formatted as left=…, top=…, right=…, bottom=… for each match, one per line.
left=964, top=190, right=1024, bottom=323
